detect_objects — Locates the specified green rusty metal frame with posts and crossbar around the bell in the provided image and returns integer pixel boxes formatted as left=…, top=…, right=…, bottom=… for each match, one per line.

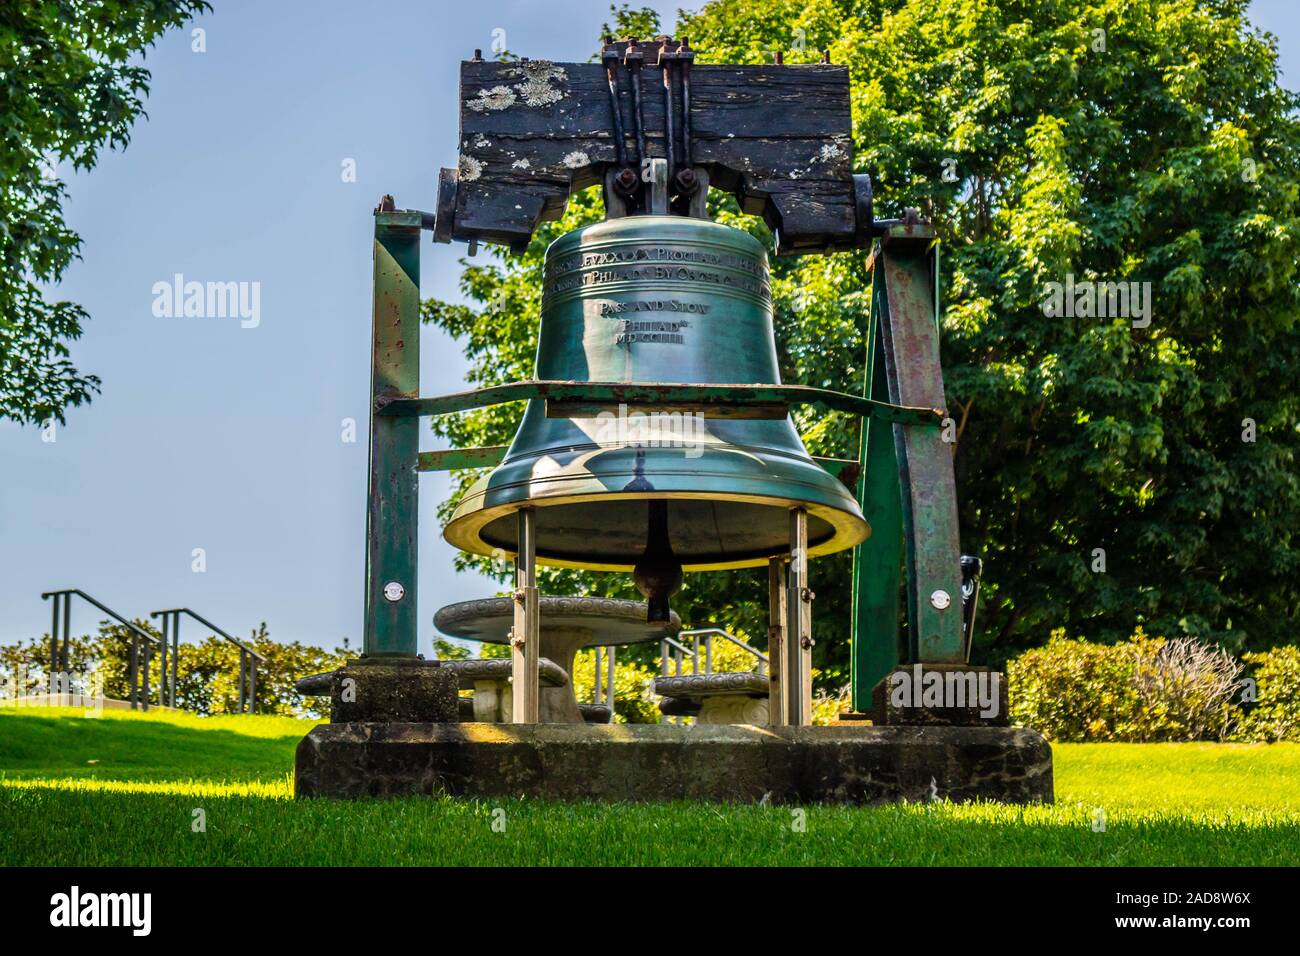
left=364, top=211, right=963, bottom=710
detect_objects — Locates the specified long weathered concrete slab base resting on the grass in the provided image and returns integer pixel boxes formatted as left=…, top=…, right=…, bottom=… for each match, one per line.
left=294, top=723, right=1053, bottom=804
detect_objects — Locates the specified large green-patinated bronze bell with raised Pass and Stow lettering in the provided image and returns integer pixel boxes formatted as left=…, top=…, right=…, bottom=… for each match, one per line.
left=443, top=216, right=868, bottom=619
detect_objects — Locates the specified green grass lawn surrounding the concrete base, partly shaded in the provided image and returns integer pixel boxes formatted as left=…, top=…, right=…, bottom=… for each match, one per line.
left=0, top=709, right=1300, bottom=866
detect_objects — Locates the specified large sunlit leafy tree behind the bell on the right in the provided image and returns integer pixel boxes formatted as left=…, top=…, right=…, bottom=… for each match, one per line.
left=426, top=0, right=1300, bottom=685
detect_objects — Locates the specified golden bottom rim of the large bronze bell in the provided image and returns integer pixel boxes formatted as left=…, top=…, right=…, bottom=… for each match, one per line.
left=442, top=492, right=871, bottom=571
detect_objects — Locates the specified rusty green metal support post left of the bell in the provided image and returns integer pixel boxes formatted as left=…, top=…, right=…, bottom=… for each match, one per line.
left=364, top=205, right=421, bottom=659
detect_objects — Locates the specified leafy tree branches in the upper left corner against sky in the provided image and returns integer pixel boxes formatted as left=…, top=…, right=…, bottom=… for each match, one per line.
left=0, top=0, right=211, bottom=424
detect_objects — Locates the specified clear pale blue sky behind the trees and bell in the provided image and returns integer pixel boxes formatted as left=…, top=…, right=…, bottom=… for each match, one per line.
left=0, top=0, right=1300, bottom=653
